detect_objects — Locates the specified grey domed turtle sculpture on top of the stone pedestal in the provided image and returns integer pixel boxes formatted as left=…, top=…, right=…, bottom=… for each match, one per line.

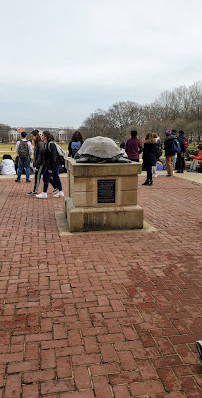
left=77, top=136, right=121, bottom=159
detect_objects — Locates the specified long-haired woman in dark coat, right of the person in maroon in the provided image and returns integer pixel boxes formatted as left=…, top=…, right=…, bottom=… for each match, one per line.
left=142, top=133, right=158, bottom=185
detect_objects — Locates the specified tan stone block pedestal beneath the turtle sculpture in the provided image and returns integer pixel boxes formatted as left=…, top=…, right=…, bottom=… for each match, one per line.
left=64, top=158, right=143, bottom=232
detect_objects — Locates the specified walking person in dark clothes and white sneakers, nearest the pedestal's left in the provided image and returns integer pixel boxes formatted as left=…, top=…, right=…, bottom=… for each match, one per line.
left=36, top=131, right=64, bottom=199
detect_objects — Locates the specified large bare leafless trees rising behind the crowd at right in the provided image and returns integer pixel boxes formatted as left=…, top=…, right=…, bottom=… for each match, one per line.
left=80, top=81, right=202, bottom=142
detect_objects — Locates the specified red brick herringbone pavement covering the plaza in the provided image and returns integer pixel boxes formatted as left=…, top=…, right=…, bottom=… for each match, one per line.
left=0, top=177, right=202, bottom=398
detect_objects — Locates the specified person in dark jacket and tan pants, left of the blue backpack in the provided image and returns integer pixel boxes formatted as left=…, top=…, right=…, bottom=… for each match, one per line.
left=164, top=130, right=179, bottom=177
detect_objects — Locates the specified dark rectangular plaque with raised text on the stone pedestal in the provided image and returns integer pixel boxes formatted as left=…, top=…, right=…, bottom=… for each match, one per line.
left=97, top=180, right=116, bottom=203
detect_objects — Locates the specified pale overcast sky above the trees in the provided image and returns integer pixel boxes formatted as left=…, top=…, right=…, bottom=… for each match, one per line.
left=0, top=0, right=202, bottom=128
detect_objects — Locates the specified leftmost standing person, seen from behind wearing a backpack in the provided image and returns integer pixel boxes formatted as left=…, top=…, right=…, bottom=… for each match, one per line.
left=15, top=131, right=32, bottom=182
